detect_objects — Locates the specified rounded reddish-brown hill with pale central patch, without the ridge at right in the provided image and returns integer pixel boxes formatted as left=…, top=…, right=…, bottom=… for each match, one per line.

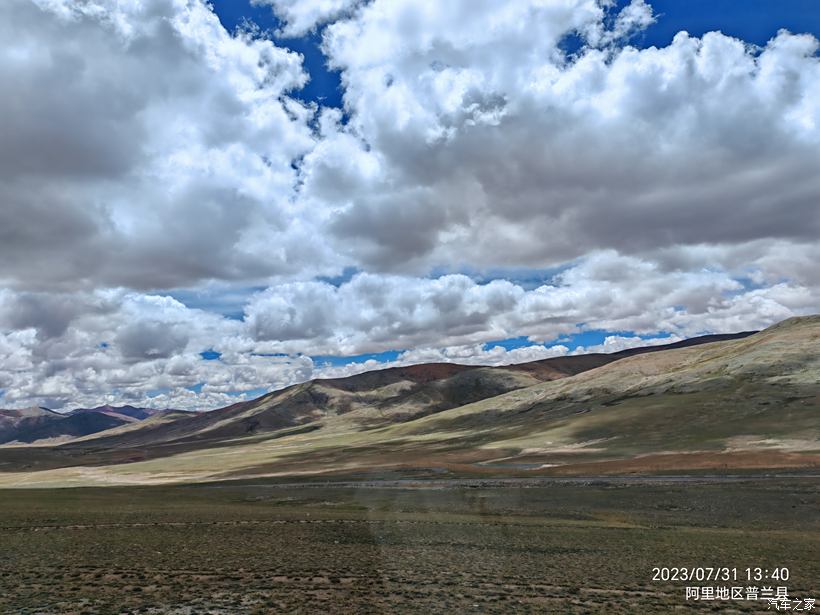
left=49, top=364, right=558, bottom=449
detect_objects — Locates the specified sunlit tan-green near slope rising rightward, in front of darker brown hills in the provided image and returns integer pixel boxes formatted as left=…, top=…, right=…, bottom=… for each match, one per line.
left=0, top=317, right=820, bottom=486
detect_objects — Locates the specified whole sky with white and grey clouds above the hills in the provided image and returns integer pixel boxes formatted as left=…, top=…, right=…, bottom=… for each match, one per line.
left=0, top=0, right=820, bottom=409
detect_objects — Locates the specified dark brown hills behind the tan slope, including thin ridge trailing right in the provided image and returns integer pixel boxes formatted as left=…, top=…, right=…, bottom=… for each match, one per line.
left=41, top=333, right=748, bottom=452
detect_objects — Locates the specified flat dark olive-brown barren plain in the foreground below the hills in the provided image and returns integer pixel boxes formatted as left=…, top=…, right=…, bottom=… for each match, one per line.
left=0, top=476, right=820, bottom=614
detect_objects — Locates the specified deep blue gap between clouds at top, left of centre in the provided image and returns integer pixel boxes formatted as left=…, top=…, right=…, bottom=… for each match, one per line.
left=211, top=0, right=342, bottom=108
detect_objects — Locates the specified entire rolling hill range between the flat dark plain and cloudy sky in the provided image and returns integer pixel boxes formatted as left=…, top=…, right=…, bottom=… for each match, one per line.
left=0, top=317, right=820, bottom=485
